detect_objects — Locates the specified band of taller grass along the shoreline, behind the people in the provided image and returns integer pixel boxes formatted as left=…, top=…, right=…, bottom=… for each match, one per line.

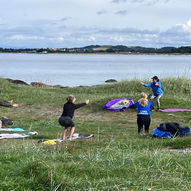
left=0, top=78, right=191, bottom=105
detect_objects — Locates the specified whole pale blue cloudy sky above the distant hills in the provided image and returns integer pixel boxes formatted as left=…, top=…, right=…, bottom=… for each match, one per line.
left=0, top=0, right=191, bottom=48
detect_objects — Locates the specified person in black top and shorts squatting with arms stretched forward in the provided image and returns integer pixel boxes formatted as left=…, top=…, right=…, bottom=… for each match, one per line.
left=58, top=95, right=89, bottom=140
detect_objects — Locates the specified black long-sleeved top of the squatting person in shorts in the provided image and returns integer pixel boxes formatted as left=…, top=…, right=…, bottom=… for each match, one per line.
left=62, top=102, right=86, bottom=118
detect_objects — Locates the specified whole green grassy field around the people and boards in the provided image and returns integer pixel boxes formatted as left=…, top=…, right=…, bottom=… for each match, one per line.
left=0, top=78, right=191, bottom=191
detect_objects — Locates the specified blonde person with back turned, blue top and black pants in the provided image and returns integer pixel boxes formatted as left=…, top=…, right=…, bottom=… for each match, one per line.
left=134, top=93, right=153, bottom=134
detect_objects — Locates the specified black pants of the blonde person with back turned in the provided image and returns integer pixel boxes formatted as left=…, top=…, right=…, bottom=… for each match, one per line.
left=137, top=115, right=151, bottom=133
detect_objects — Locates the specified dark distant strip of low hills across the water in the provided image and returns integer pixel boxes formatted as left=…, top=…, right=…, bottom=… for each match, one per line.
left=0, top=45, right=191, bottom=54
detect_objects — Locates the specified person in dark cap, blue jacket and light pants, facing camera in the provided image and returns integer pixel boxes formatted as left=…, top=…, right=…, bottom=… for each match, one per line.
left=141, top=76, right=163, bottom=111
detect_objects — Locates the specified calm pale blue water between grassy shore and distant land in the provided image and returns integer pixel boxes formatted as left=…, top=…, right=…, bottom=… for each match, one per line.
left=0, top=54, right=191, bottom=86
